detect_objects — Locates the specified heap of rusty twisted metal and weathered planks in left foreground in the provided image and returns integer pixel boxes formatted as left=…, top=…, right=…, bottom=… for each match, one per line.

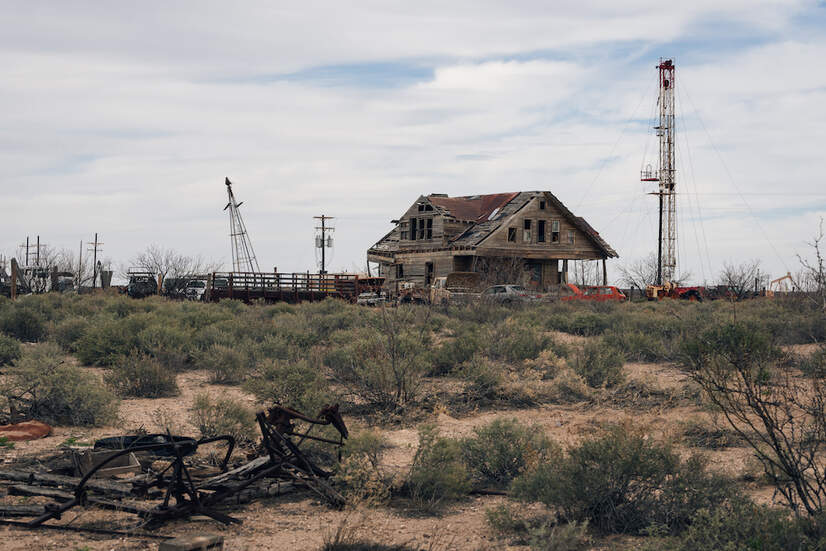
left=0, top=405, right=348, bottom=533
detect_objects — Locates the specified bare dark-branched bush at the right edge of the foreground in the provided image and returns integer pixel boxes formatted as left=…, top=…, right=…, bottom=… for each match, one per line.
left=685, top=324, right=826, bottom=514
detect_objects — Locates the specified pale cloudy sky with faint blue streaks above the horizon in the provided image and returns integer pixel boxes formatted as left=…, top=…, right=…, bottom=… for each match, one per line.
left=0, top=0, right=826, bottom=280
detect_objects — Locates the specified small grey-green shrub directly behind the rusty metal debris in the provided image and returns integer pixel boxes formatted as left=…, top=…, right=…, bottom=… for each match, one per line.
left=190, top=392, right=256, bottom=442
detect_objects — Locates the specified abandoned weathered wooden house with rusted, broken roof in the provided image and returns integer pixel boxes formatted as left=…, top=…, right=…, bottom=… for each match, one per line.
left=367, top=191, right=618, bottom=290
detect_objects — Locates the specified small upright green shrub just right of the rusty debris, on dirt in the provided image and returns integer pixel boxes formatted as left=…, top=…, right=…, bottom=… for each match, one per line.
left=405, top=425, right=471, bottom=512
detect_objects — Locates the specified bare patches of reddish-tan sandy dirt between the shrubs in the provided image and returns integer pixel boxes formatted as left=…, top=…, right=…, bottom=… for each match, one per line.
left=0, top=350, right=772, bottom=551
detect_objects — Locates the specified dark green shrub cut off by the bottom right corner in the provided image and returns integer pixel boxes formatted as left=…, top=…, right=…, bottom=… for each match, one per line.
left=673, top=499, right=826, bottom=551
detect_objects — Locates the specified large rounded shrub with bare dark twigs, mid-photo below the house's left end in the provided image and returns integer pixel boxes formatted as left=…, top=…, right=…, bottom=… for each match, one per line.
left=324, top=308, right=431, bottom=411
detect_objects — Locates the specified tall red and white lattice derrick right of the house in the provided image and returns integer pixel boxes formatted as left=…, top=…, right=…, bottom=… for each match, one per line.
left=640, top=59, right=677, bottom=285
